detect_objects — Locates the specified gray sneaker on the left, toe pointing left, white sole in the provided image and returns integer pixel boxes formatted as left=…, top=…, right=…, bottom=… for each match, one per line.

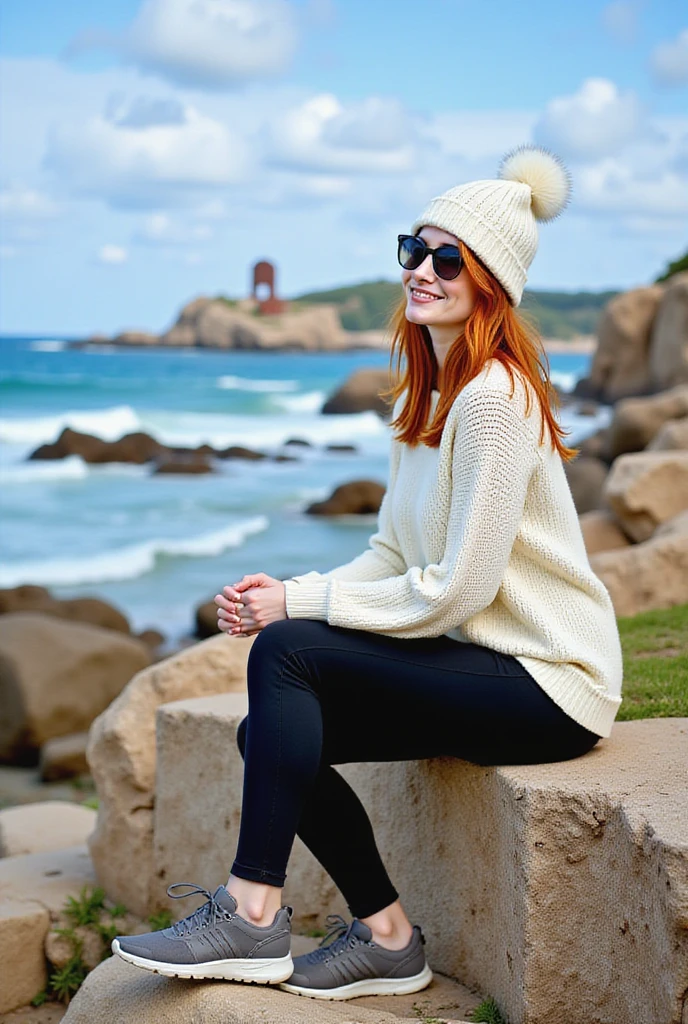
left=113, top=882, right=294, bottom=984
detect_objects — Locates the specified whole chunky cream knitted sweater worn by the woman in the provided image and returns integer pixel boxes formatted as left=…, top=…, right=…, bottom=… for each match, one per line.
left=285, top=359, right=622, bottom=736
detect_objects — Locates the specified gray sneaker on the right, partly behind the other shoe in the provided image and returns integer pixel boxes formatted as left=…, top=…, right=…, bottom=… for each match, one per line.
left=280, top=913, right=432, bottom=999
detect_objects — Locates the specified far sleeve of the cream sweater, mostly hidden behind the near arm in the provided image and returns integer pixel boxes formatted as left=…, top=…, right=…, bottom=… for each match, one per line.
left=284, top=423, right=406, bottom=585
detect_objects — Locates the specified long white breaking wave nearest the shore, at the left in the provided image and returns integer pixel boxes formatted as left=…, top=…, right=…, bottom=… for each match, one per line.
left=0, top=515, right=269, bottom=587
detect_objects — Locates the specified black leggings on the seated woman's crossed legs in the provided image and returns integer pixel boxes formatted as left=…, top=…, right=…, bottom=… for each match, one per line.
left=231, top=618, right=599, bottom=918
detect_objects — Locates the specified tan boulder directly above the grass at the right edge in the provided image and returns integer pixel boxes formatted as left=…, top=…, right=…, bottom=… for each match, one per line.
left=590, top=513, right=688, bottom=615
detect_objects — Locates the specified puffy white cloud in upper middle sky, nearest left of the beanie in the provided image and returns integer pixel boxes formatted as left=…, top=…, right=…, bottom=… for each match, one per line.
left=271, top=93, right=414, bottom=174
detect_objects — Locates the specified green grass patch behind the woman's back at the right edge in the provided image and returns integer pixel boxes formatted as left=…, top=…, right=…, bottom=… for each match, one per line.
left=617, top=604, right=688, bottom=722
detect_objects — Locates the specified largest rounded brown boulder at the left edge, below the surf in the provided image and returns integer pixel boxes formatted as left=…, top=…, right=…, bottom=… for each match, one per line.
left=0, top=611, right=151, bottom=764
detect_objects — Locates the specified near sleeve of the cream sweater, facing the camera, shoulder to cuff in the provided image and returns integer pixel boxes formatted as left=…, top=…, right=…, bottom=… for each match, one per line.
left=286, top=388, right=539, bottom=639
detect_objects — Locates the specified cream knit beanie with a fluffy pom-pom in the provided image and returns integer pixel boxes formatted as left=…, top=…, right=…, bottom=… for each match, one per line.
left=412, top=145, right=571, bottom=306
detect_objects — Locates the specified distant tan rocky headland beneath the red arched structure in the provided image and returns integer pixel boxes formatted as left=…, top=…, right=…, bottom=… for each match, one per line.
left=89, top=297, right=387, bottom=351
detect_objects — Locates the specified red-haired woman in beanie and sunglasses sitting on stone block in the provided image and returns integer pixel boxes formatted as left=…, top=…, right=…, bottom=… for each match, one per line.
left=115, top=146, right=621, bottom=999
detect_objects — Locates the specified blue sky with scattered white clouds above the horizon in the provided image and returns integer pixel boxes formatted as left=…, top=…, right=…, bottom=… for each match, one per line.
left=0, top=0, right=688, bottom=335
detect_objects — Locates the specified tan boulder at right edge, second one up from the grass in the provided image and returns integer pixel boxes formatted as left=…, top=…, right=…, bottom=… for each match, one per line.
left=604, top=452, right=688, bottom=542
